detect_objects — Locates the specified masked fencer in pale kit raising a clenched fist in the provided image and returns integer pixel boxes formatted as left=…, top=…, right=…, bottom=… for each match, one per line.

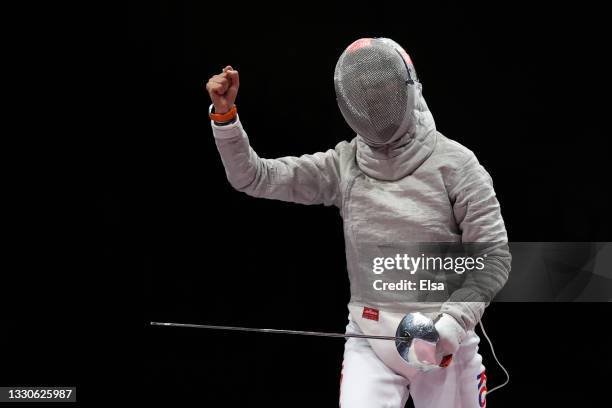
left=206, top=38, right=511, bottom=408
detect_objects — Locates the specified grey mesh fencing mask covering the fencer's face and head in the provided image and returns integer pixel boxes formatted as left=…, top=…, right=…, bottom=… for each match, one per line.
left=334, top=38, right=419, bottom=146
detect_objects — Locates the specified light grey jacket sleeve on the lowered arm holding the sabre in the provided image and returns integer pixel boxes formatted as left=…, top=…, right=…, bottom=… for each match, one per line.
left=441, top=152, right=512, bottom=330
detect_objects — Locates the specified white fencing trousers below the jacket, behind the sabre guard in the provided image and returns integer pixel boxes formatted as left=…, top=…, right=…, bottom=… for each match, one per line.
left=340, top=320, right=487, bottom=408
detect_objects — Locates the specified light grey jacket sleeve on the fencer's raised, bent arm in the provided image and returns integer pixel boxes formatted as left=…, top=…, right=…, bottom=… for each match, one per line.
left=211, top=118, right=340, bottom=206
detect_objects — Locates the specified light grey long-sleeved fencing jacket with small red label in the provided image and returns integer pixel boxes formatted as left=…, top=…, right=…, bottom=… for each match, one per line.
left=211, top=90, right=511, bottom=370
